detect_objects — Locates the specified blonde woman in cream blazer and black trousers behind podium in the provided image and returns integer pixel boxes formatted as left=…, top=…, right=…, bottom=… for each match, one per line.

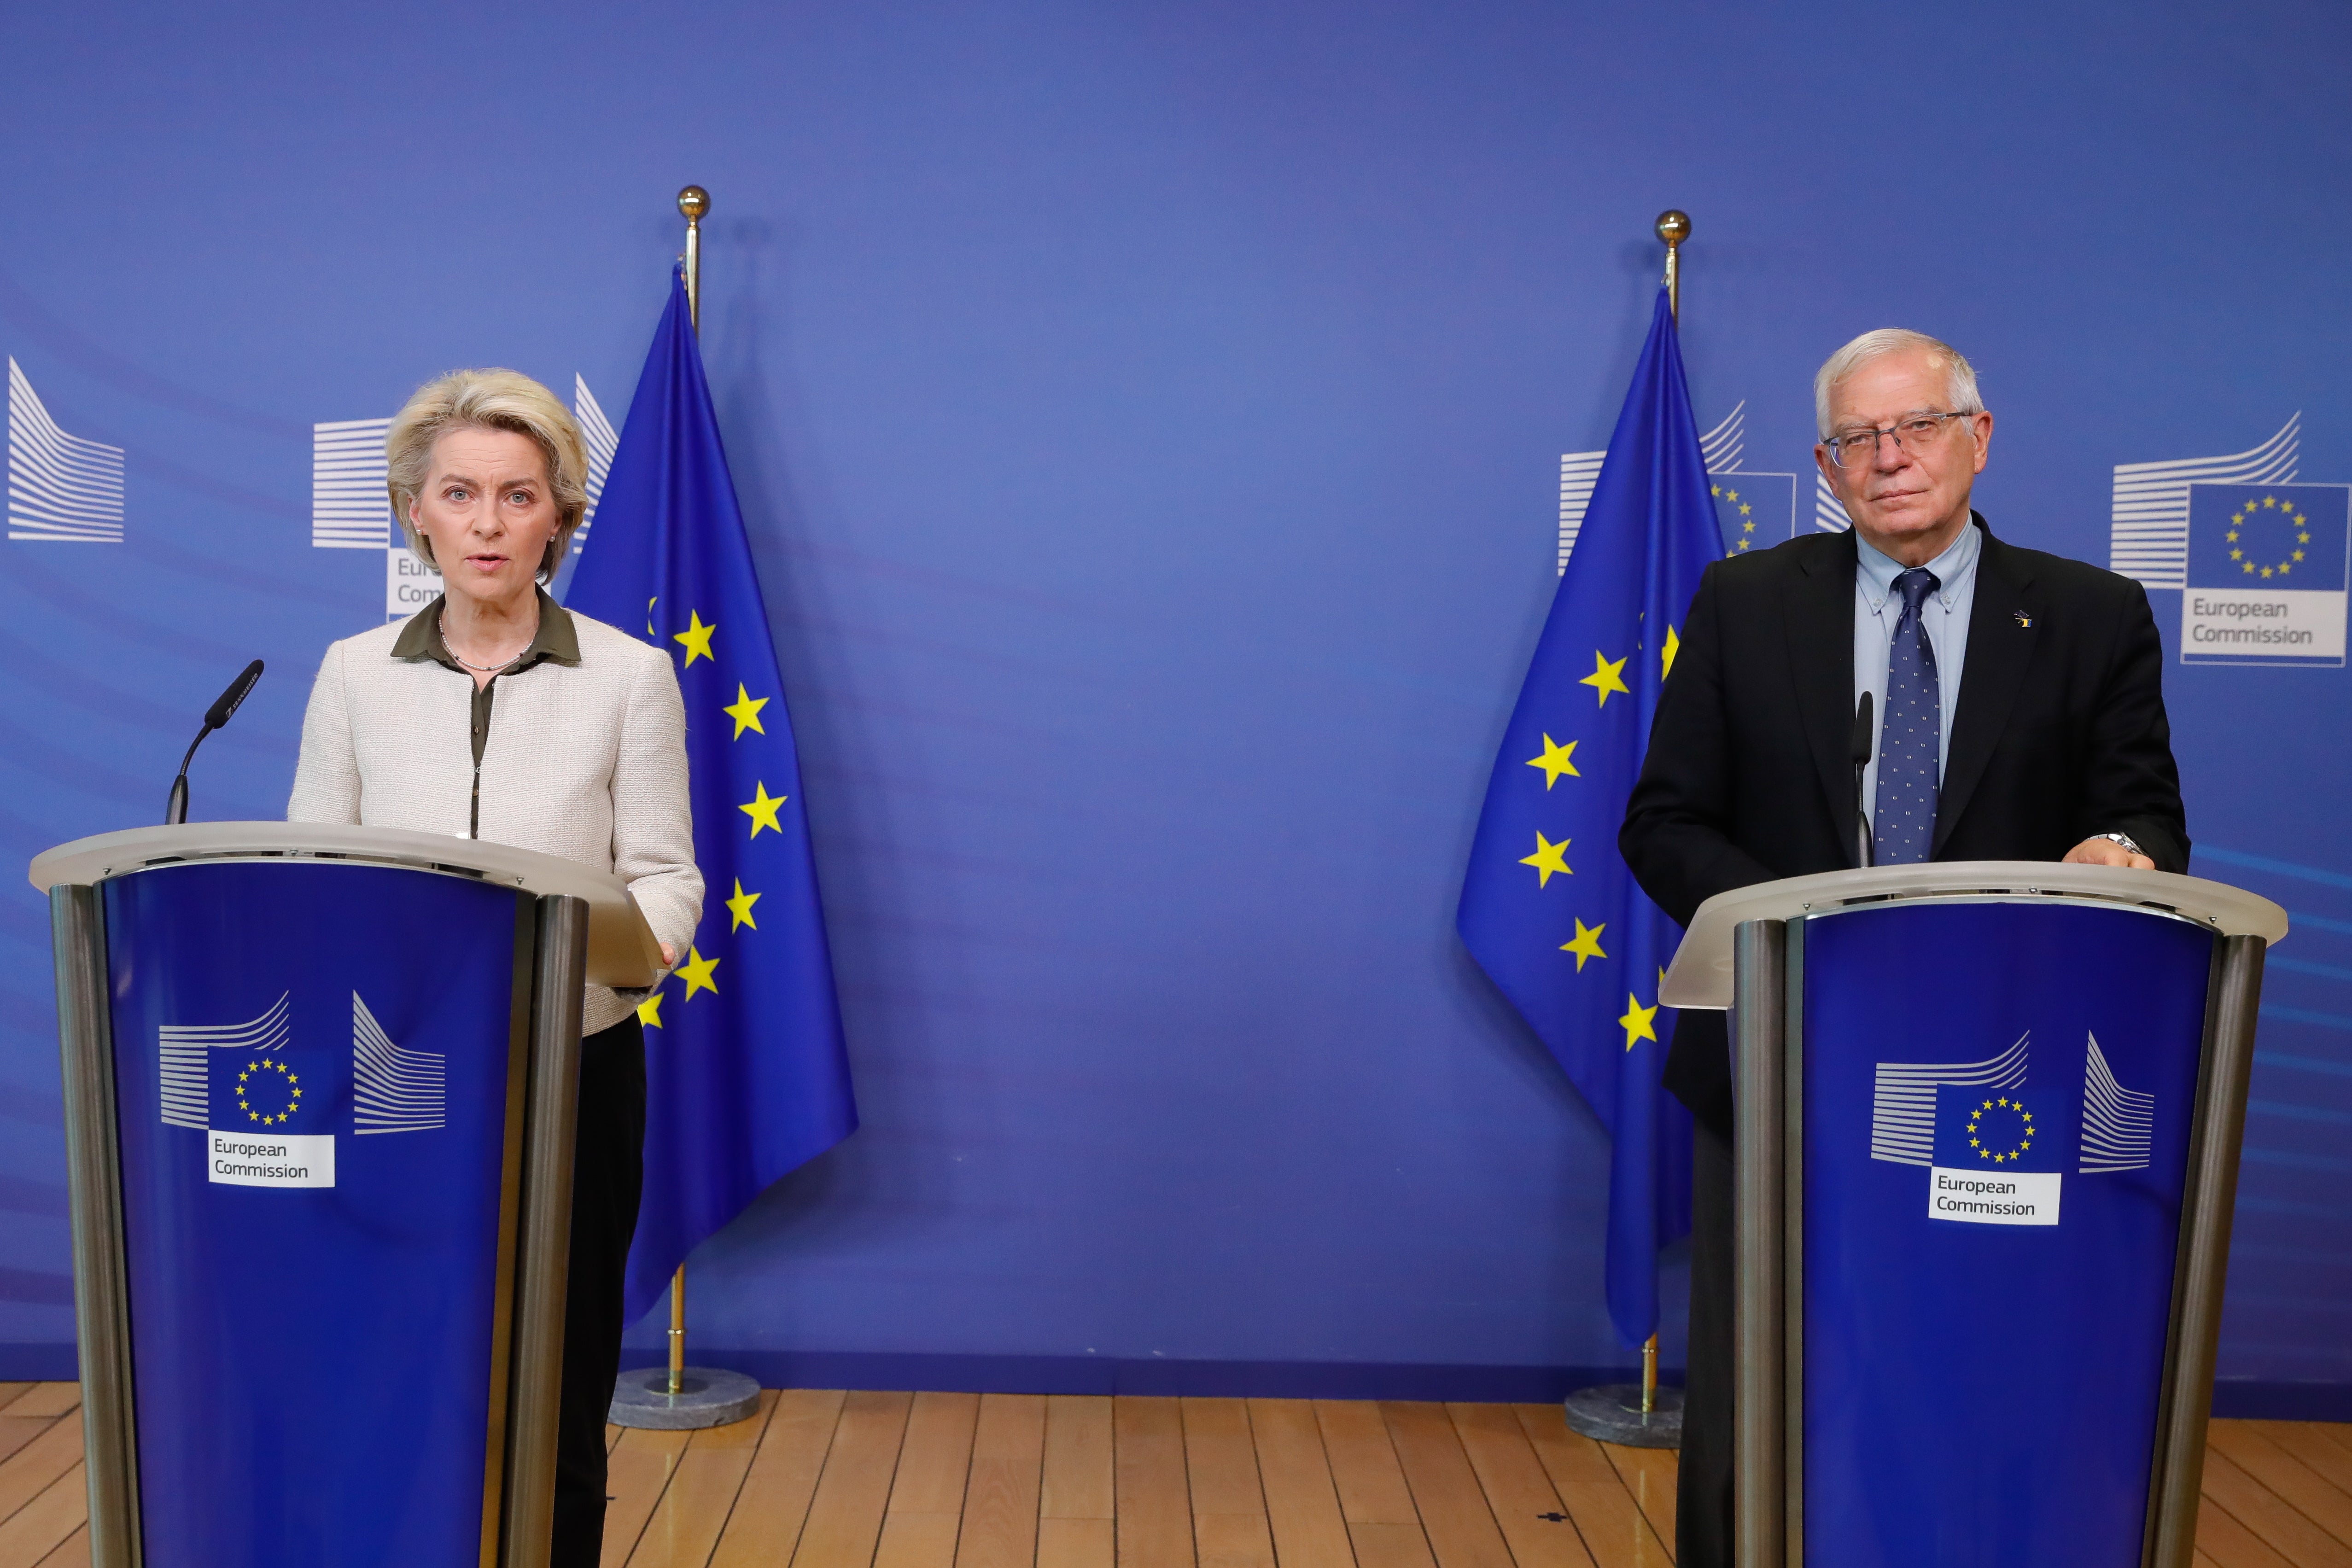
left=287, top=369, right=703, bottom=1568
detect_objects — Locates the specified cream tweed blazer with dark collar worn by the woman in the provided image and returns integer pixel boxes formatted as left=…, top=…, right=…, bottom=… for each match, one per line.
left=287, top=613, right=703, bottom=1034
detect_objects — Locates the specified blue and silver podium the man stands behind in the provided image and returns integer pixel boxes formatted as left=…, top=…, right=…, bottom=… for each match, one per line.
left=1661, top=860, right=2286, bottom=1568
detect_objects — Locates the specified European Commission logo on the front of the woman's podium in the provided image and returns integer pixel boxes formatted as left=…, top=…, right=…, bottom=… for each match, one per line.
left=155, top=992, right=449, bottom=1187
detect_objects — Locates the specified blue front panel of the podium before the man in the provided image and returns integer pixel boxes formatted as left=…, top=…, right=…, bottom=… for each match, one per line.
left=1802, top=903, right=2213, bottom=1568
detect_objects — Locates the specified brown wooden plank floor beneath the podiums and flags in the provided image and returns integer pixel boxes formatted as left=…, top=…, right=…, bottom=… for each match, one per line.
left=0, top=1382, right=2352, bottom=1568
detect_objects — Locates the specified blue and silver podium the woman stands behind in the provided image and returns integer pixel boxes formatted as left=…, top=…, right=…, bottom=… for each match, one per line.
left=30, top=823, right=661, bottom=1568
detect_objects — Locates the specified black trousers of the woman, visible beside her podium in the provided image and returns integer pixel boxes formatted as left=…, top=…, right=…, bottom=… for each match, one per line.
left=548, top=1015, right=644, bottom=1568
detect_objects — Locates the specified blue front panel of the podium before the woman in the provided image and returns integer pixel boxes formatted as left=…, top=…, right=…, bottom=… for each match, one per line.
left=104, top=860, right=527, bottom=1568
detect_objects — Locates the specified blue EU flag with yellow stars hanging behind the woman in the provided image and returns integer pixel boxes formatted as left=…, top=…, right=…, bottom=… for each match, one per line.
left=567, top=273, right=858, bottom=1319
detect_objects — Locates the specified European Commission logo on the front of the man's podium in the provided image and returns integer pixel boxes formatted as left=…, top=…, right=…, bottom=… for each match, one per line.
left=1870, top=1032, right=2157, bottom=1225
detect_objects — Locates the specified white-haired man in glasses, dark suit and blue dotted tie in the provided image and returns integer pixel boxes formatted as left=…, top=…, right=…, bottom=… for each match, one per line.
left=1618, top=327, right=2190, bottom=1568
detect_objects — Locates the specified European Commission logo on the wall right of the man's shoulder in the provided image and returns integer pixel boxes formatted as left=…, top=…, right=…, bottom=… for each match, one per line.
left=2107, top=414, right=2352, bottom=665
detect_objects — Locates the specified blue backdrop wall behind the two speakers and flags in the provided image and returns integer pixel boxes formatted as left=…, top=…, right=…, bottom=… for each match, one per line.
left=0, top=0, right=2352, bottom=1413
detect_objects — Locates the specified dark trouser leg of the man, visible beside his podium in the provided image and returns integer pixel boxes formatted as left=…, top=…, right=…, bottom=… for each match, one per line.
left=1675, top=1121, right=1736, bottom=1568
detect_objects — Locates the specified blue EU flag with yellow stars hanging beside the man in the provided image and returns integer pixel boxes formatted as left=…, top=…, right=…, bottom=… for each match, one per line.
left=1458, top=289, right=1722, bottom=1345
